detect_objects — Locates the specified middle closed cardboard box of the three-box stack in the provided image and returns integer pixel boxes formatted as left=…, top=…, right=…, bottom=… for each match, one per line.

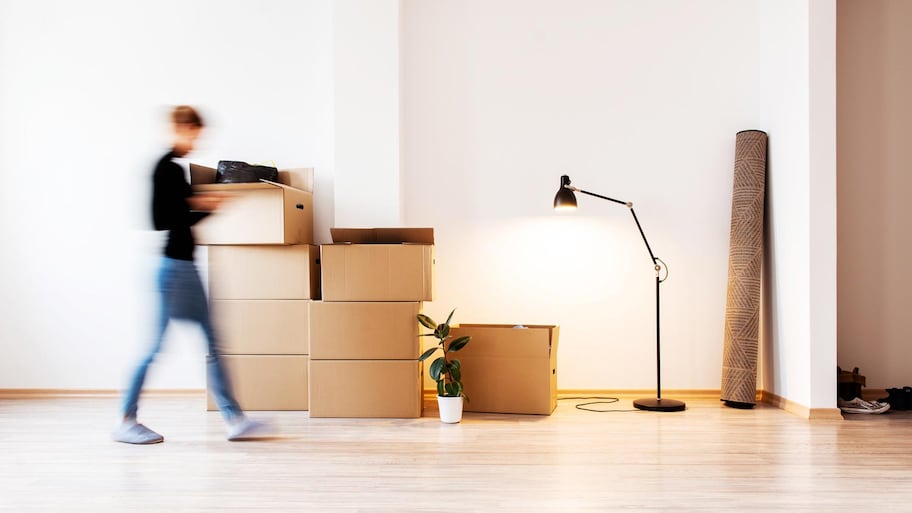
left=309, top=301, right=421, bottom=360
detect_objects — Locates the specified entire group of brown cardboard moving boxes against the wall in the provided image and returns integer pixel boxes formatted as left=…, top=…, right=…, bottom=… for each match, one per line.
left=190, top=164, right=558, bottom=418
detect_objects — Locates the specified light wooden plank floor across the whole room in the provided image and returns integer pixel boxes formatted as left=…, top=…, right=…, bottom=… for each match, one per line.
left=0, top=396, right=912, bottom=513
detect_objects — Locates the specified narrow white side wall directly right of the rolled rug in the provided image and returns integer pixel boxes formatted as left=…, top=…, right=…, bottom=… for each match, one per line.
left=763, top=7, right=810, bottom=405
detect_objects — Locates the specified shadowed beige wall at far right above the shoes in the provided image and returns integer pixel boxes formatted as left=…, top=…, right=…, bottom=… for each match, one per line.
left=836, top=0, right=912, bottom=388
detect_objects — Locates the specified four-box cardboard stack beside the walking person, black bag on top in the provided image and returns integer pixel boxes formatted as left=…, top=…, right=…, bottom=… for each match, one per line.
left=190, top=164, right=320, bottom=410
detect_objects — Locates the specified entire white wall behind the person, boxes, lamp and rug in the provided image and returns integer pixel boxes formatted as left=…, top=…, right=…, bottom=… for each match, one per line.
left=0, top=0, right=835, bottom=406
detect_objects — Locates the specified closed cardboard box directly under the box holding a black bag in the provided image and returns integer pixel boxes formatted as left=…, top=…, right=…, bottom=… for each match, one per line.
left=209, top=244, right=320, bottom=299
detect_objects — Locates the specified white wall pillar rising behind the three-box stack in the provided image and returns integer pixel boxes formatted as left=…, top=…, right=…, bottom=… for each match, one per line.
left=333, top=0, right=402, bottom=227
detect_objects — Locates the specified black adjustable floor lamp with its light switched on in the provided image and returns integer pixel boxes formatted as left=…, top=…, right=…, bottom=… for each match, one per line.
left=554, top=175, right=685, bottom=411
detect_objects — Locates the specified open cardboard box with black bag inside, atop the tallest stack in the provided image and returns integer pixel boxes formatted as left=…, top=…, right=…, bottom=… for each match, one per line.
left=190, top=164, right=314, bottom=245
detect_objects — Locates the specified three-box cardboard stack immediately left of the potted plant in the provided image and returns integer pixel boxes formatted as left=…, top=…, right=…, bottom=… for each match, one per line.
left=310, top=228, right=434, bottom=418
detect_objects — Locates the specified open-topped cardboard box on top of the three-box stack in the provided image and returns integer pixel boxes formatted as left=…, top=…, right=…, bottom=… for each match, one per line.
left=321, top=228, right=434, bottom=301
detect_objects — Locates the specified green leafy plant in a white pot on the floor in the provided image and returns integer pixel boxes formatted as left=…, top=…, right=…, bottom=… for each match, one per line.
left=418, top=309, right=472, bottom=424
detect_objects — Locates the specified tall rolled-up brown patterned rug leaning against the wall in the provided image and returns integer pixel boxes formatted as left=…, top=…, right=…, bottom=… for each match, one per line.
left=722, top=130, right=767, bottom=408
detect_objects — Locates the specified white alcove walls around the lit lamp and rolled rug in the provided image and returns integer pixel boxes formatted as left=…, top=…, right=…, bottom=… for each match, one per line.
left=401, top=0, right=832, bottom=396
